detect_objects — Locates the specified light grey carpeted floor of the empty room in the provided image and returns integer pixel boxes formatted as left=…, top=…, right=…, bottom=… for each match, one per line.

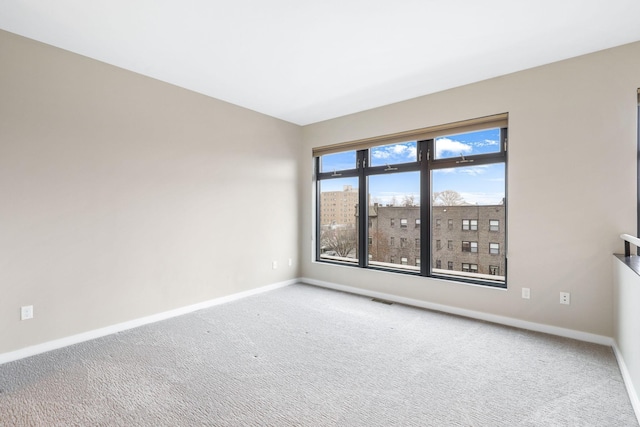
left=0, top=285, right=638, bottom=427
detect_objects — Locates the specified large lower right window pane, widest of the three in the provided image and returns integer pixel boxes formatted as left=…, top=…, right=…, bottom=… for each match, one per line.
left=431, top=163, right=505, bottom=282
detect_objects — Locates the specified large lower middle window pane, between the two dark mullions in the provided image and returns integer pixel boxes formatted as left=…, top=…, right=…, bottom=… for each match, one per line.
left=368, top=172, right=420, bottom=272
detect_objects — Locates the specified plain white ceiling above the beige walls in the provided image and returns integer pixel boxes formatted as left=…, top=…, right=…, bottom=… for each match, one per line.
left=0, top=0, right=640, bottom=125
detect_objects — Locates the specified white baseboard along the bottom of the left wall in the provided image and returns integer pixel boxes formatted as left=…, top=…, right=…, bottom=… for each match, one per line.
left=0, top=279, right=300, bottom=365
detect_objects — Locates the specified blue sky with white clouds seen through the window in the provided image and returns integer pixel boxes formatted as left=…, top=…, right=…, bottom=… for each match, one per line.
left=321, top=129, right=505, bottom=205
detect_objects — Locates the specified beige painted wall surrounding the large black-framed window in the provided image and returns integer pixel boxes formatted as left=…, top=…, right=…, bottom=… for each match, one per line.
left=301, top=43, right=640, bottom=337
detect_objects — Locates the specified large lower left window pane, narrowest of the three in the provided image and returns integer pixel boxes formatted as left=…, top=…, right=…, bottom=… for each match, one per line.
left=319, top=178, right=358, bottom=262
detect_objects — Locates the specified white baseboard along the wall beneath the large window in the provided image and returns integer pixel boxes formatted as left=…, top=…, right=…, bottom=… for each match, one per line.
left=300, top=277, right=613, bottom=346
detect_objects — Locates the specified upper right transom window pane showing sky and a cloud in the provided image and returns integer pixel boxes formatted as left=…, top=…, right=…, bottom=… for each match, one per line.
left=434, top=128, right=500, bottom=160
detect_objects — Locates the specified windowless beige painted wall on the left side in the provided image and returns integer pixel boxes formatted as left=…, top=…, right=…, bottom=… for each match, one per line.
left=0, top=31, right=301, bottom=353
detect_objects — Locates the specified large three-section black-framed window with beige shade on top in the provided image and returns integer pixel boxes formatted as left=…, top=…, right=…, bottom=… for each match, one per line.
left=313, top=114, right=507, bottom=287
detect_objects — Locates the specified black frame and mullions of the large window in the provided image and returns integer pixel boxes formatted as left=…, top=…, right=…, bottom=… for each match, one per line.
left=314, top=126, right=508, bottom=288
